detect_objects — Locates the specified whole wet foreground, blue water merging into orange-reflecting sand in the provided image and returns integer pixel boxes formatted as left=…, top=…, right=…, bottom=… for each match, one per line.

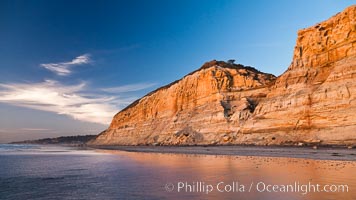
left=0, top=144, right=356, bottom=200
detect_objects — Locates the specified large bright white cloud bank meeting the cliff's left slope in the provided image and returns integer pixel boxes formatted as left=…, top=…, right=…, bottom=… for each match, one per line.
left=0, top=80, right=119, bottom=124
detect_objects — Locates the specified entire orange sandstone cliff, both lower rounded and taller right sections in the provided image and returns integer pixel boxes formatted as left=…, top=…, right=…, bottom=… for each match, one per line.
left=91, top=6, right=356, bottom=145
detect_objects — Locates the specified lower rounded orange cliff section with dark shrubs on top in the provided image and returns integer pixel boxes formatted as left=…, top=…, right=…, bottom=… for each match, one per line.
left=95, top=61, right=275, bottom=145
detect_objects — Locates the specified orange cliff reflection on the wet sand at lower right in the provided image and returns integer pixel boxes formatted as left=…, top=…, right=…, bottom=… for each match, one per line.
left=98, top=150, right=356, bottom=199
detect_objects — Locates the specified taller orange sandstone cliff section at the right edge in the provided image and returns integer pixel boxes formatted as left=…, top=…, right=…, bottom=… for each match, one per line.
left=241, top=6, right=356, bottom=144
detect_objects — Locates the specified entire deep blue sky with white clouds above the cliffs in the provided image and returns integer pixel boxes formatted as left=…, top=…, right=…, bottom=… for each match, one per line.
left=0, top=0, right=352, bottom=143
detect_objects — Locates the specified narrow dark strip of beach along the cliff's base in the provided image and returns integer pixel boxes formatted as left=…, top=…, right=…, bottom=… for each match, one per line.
left=87, top=145, right=356, bottom=161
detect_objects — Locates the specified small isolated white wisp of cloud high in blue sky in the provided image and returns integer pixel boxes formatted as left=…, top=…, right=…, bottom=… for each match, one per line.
left=41, top=54, right=91, bottom=76
